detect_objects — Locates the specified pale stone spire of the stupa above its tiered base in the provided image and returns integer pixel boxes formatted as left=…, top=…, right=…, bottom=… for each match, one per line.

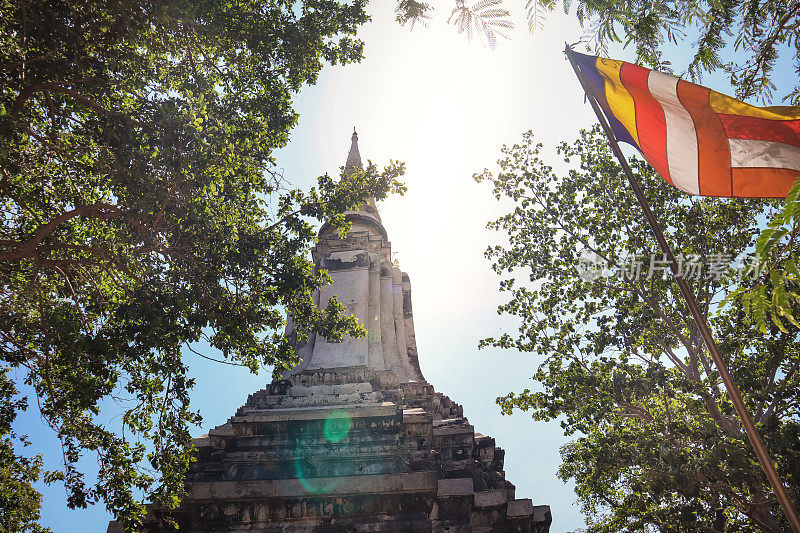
left=292, top=128, right=425, bottom=384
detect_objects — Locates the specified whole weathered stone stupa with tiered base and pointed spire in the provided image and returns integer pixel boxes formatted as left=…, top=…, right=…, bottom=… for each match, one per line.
left=133, top=132, right=551, bottom=533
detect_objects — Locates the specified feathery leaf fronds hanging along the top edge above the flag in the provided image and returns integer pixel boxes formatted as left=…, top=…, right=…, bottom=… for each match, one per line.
left=397, top=0, right=800, bottom=105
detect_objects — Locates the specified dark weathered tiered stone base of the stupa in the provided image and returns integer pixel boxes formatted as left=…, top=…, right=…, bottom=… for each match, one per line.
left=130, top=368, right=551, bottom=533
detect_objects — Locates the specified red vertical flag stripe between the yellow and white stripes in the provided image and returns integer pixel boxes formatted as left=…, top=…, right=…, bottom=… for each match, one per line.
left=619, top=63, right=672, bottom=184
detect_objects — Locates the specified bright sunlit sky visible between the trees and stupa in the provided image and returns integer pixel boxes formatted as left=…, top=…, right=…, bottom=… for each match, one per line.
left=21, top=0, right=784, bottom=533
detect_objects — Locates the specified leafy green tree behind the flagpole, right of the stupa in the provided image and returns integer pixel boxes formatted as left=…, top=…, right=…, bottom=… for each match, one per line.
left=476, top=127, right=800, bottom=532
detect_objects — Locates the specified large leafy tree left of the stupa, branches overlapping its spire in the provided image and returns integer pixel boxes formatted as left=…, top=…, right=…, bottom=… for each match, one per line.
left=0, top=0, right=403, bottom=530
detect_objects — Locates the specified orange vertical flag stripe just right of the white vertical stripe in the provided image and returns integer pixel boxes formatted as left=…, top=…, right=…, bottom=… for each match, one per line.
left=678, top=80, right=734, bottom=196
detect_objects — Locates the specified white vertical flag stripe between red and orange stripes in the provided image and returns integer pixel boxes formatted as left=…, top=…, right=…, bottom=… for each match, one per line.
left=647, top=70, right=700, bottom=194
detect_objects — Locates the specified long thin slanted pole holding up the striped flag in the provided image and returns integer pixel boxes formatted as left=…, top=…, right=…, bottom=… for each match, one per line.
left=564, top=45, right=800, bottom=533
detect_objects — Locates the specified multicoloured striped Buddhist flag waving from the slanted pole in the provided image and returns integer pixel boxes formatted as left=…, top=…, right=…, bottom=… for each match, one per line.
left=570, top=52, right=800, bottom=198
